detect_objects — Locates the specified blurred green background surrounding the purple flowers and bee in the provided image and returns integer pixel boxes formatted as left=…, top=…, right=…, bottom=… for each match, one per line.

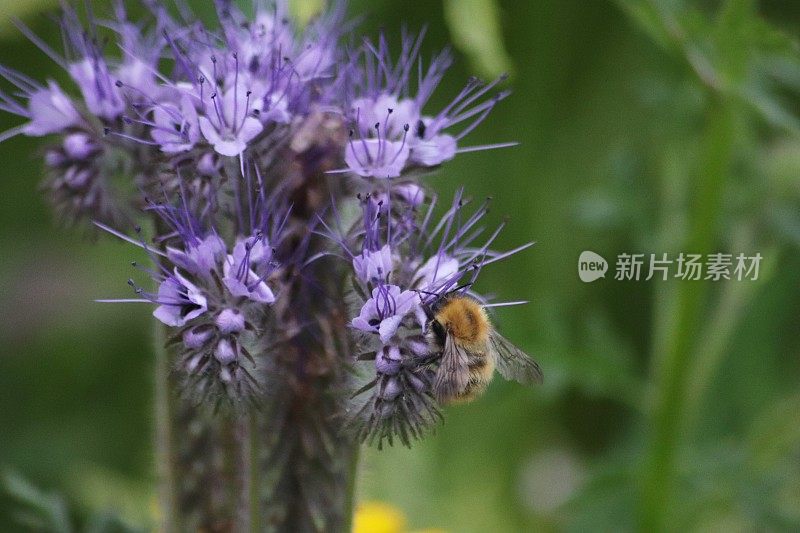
left=0, top=0, right=800, bottom=532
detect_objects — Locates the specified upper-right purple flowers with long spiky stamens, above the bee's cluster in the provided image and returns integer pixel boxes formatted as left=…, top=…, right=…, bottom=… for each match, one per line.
left=345, top=34, right=510, bottom=178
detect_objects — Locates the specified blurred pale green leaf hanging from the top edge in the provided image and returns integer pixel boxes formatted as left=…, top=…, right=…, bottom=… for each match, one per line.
left=444, top=0, right=513, bottom=77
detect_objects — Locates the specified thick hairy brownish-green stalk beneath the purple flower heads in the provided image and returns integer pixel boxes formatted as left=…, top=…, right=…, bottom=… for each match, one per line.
left=156, top=324, right=357, bottom=533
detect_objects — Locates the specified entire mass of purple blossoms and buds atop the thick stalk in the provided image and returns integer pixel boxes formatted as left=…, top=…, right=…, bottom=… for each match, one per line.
left=0, top=0, right=532, bottom=436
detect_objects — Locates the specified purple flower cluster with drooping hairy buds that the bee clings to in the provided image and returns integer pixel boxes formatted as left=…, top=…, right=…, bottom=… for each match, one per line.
left=331, top=189, right=527, bottom=446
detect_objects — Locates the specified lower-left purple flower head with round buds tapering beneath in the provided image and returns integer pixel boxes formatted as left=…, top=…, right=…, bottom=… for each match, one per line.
left=99, top=171, right=289, bottom=400
